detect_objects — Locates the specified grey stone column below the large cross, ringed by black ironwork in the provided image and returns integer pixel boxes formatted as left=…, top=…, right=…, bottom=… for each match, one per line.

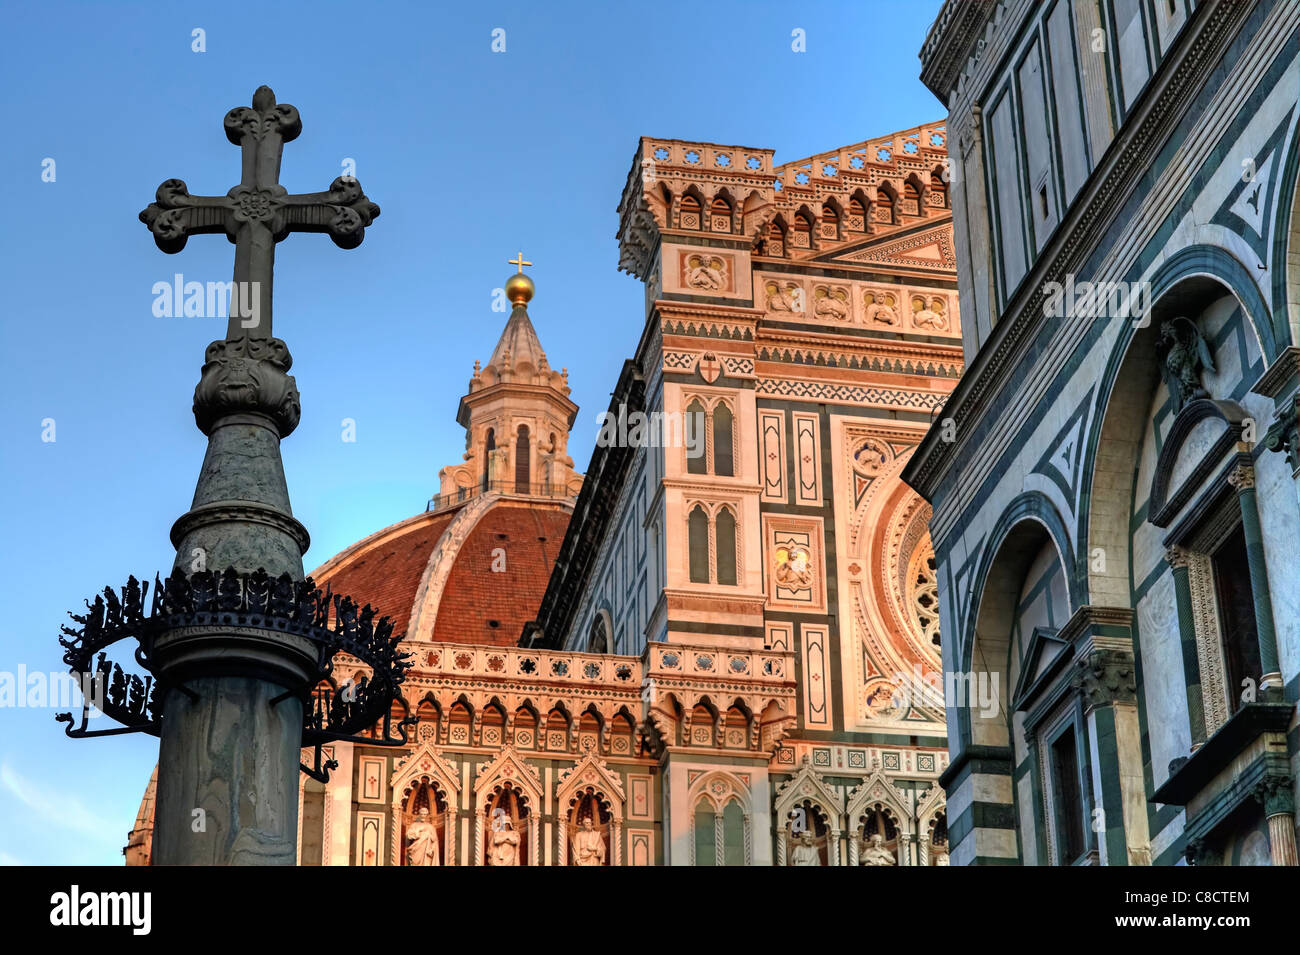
left=153, top=350, right=316, bottom=865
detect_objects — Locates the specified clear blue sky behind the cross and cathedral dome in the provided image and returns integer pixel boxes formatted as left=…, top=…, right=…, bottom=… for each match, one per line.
left=0, top=0, right=944, bottom=865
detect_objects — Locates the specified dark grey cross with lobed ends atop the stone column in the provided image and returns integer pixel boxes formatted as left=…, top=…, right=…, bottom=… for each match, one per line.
left=140, top=86, right=380, bottom=342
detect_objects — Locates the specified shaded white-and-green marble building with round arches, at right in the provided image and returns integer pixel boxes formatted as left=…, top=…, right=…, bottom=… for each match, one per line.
left=905, top=0, right=1300, bottom=865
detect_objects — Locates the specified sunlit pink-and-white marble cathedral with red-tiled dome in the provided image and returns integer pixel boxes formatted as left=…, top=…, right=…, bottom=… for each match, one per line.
left=127, top=123, right=962, bottom=865
